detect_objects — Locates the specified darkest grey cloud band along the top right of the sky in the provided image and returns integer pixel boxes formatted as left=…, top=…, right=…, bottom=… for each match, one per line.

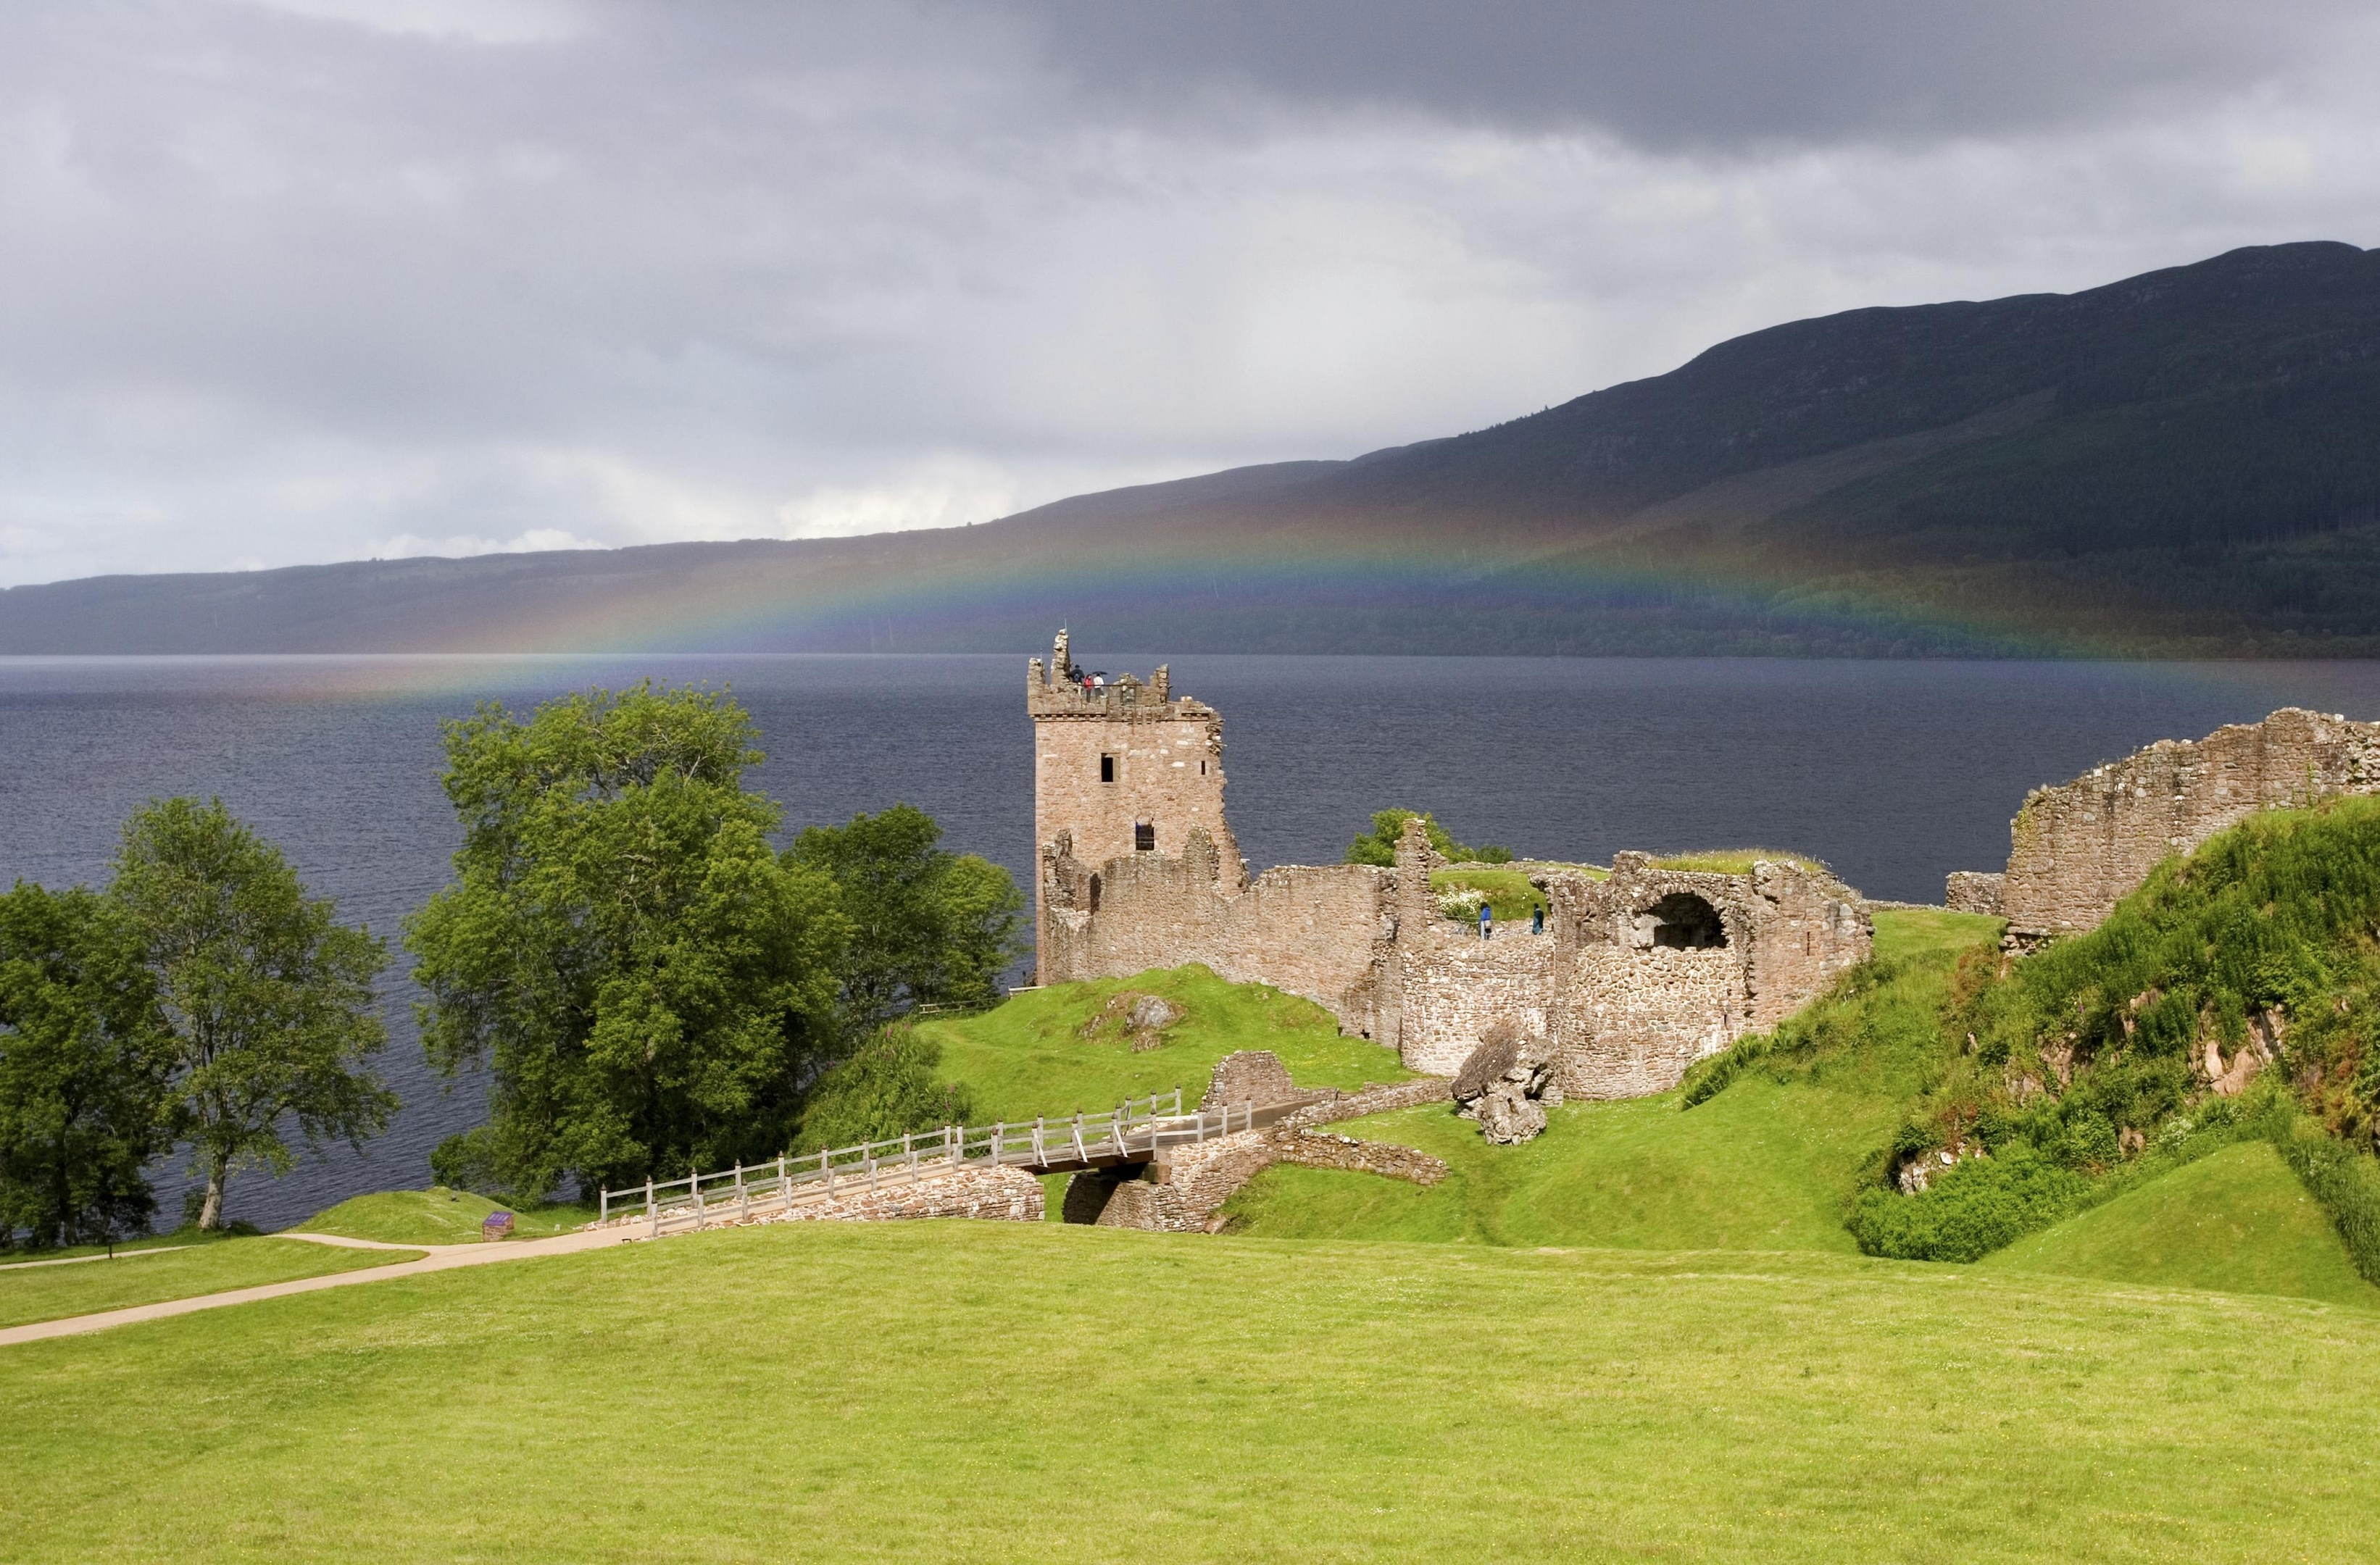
left=1014, top=0, right=2368, bottom=150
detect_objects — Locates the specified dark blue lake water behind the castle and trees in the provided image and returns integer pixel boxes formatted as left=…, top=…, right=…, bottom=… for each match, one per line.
left=0, top=649, right=2380, bottom=1227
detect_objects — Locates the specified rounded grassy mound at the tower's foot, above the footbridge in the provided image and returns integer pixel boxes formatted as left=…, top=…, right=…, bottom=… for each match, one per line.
left=919, top=963, right=1411, bottom=1122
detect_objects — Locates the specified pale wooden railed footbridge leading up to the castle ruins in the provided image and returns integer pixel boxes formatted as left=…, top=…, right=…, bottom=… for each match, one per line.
left=597, top=1087, right=1305, bottom=1237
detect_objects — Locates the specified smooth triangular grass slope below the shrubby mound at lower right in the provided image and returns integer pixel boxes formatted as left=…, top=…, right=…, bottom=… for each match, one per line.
left=1980, top=1142, right=2380, bottom=1308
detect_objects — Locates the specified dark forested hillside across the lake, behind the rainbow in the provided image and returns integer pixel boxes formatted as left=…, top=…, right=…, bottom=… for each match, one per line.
left=0, top=243, right=2380, bottom=656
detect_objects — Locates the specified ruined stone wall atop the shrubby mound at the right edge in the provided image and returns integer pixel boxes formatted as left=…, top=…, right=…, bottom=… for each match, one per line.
left=2000, top=706, right=2380, bottom=944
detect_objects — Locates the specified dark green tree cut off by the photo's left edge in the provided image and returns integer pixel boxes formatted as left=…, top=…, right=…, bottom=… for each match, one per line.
left=0, top=882, right=174, bottom=1248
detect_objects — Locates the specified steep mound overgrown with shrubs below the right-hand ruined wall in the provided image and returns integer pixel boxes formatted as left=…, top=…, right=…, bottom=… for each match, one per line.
left=1852, top=799, right=2380, bottom=1280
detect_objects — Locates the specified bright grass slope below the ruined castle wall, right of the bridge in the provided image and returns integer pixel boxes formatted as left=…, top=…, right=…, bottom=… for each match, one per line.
left=1226, top=911, right=2000, bottom=1253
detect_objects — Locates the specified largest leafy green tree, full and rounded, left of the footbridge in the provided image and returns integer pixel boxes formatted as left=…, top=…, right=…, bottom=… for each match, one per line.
left=404, top=683, right=847, bottom=1196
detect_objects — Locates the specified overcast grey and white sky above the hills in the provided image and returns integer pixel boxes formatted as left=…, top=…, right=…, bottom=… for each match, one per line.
left=0, top=0, right=2380, bottom=585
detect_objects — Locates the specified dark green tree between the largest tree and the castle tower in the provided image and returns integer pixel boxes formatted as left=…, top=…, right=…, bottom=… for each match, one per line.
left=788, top=804, right=1025, bottom=1030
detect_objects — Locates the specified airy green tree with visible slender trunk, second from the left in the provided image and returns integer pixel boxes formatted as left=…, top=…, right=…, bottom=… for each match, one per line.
left=107, top=799, right=397, bottom=1227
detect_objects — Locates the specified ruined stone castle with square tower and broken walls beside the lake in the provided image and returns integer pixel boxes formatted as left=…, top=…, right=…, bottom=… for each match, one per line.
left=1025, top=633, right=1873, bottom=1099
